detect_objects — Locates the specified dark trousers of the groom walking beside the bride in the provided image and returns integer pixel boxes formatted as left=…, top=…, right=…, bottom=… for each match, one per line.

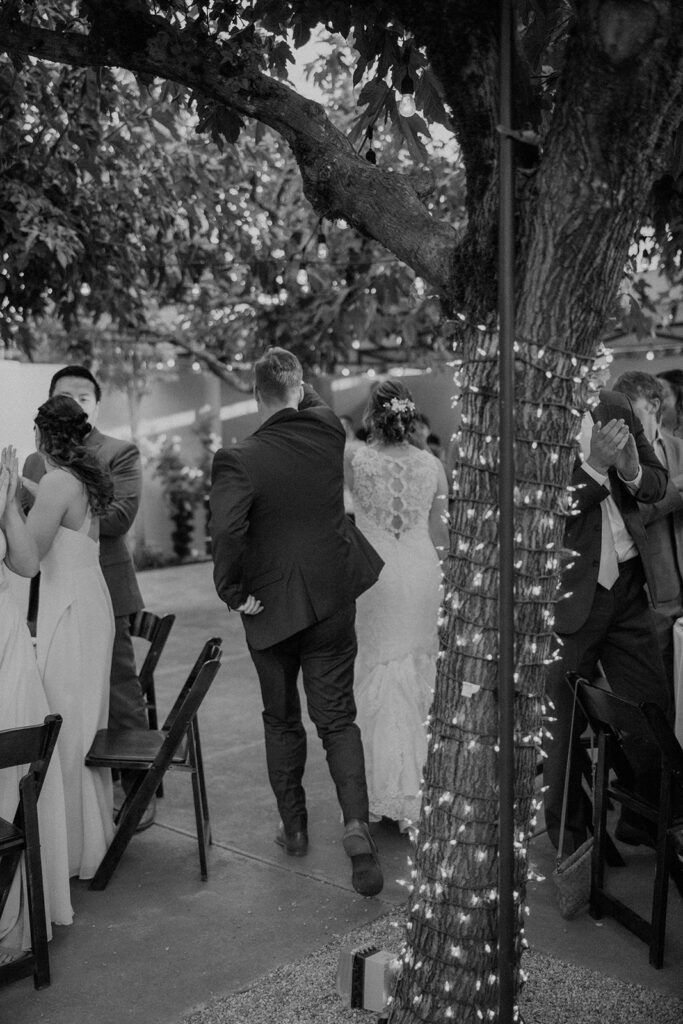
left=250, top=601, right=369, bottom=833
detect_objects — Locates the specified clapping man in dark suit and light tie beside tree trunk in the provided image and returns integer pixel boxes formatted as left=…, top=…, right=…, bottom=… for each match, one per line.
left=544, top=391, right=671, bottom=853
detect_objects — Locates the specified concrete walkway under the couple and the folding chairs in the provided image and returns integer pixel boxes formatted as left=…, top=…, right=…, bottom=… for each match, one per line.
left=0, top=563, right=683, bottom=1024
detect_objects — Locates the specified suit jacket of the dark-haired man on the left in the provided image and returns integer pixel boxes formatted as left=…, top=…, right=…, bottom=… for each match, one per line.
left=23, top=427, right=144, bottom=615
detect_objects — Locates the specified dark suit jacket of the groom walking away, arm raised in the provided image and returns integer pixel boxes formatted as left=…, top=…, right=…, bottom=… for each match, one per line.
left=211, top=386, right=383, bottom=650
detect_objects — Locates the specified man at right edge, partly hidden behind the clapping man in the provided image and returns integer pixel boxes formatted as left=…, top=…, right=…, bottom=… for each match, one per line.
left=614, top=370, right=683, bottom=694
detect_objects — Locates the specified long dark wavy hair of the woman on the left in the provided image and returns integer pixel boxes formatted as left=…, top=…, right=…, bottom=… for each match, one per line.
left=34, top=394, right=114, bottom=515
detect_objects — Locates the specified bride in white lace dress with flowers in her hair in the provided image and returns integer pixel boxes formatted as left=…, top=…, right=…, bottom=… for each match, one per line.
left=346, top=379, right=449, bottom=830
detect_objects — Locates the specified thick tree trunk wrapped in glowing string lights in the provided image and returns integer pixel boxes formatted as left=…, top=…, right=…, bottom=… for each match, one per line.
left=390, top=18, right=681, bottom=1024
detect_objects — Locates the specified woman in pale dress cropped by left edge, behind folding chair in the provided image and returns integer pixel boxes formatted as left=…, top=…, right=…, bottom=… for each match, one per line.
left=0, top=449, right=74, bottom=964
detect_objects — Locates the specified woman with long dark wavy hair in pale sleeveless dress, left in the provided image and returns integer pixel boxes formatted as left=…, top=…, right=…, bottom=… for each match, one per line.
left=24, top=394, right=114, bottom=879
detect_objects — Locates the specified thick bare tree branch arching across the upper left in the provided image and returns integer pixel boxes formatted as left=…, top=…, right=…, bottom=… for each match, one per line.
left=0, top=12, right=458, bottom=294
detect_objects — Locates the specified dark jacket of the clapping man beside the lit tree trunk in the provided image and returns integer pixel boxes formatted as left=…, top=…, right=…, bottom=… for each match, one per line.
left=555, top=391, right=669, bottom=634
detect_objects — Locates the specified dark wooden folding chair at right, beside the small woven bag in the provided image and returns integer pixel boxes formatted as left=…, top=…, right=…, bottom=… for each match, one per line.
left=567, top=673, right=683, bottom=968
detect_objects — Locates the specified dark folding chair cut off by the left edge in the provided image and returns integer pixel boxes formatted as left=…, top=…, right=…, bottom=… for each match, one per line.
left=0, top=715, right=61, bottom=988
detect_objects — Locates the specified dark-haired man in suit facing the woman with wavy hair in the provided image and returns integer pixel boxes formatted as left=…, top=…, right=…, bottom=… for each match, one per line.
left=23, top=366, right=154, bottom=827
